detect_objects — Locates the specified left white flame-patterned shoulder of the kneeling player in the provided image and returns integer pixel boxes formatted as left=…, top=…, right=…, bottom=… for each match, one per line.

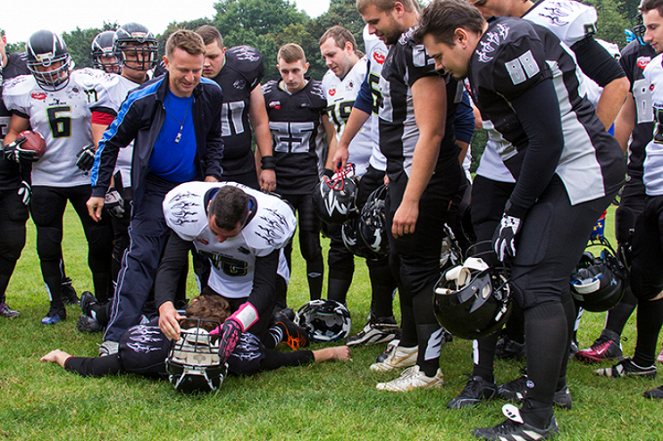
left=163, top=182, right=211, bottom=241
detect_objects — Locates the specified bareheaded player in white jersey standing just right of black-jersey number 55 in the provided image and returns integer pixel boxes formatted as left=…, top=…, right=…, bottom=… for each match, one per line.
left=320, top=26, right=398, bottom=346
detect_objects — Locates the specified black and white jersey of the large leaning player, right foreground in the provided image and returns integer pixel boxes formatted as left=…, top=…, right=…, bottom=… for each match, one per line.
left=468, top=17, right=623, bottom=205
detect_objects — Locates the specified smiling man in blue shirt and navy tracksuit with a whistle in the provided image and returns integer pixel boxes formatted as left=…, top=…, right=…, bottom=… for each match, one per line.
left=87, top=30, right=223, bottom=353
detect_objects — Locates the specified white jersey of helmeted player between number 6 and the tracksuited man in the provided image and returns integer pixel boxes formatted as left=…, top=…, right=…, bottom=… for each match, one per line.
left=76, top=68, right=140, bottom=188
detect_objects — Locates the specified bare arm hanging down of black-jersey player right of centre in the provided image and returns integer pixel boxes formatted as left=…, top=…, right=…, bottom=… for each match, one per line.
left=391, top=76, right=447, bottom=237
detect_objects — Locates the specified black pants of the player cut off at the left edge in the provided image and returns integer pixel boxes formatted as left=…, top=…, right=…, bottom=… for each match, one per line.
left=0, top=189, right=29, bottom=302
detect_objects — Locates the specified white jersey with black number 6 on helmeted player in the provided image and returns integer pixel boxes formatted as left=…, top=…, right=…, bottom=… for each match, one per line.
left=2, top=71, right=94, bottom=187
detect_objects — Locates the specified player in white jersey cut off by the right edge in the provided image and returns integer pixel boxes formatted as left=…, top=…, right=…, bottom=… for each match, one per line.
left=596, top=0, right=663, bottom=399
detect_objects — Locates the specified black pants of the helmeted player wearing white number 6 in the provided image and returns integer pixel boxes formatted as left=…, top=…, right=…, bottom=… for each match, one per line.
left=30, top=185, right=113, bottom=307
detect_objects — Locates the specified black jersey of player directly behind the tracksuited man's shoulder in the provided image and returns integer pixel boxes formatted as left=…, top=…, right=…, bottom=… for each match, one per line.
left=213, top=46, right=265, bottom=178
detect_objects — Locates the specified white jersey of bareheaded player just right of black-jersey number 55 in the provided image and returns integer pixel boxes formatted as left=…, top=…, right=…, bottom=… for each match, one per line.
left=322, top=57, right=373, bottom=176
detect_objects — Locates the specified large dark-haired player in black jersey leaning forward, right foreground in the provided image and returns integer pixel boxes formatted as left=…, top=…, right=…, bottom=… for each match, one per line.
left=417, top=0, right=625, bottom=440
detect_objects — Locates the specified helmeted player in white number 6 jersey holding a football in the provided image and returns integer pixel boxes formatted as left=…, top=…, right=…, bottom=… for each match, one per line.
left=3, top=30, right=112, bottom=324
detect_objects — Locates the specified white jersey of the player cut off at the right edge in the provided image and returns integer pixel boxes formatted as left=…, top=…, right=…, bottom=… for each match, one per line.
left=643, top=55, right=663, bottom=196
